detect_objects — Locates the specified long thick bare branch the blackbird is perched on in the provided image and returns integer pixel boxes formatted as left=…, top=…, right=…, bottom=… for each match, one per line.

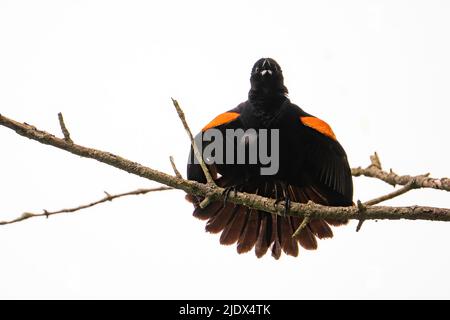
left=0, top=111, right=450, bottom=226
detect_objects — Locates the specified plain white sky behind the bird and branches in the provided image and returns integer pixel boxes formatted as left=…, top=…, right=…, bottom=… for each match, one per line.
left=0, top=0, right=450, bottom=299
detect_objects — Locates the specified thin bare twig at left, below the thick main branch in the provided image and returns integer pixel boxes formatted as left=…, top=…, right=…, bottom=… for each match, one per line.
left=0, top=187, right=174, bottom=225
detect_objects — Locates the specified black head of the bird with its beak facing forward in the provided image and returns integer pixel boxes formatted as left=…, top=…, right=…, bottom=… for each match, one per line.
left=250, top=58, right=288, bottom=99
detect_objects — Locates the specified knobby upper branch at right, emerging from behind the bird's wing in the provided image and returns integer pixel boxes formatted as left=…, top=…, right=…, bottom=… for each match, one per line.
left=352, top=153, right=450, bottom=191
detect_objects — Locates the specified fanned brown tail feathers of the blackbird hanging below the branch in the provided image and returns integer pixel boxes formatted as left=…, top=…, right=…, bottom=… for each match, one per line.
left=193, top=179, right=347, bottom=259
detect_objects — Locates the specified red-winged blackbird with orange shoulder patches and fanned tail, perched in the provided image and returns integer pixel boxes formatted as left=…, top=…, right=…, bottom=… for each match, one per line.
left=187, top=58, right=353, bottom=259
